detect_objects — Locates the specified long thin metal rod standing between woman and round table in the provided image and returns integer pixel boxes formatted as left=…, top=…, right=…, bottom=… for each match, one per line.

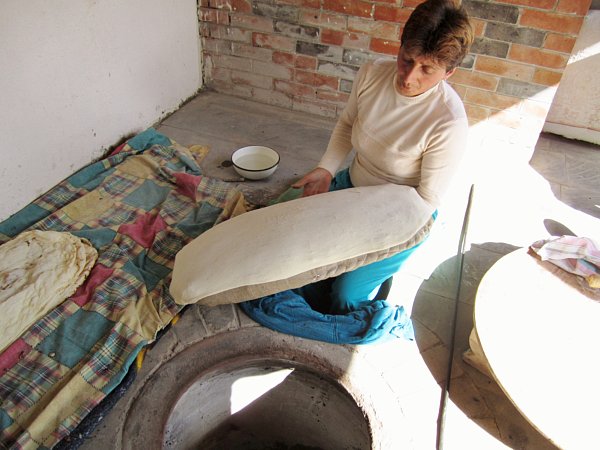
left=436, top=185, right=475, bottom=450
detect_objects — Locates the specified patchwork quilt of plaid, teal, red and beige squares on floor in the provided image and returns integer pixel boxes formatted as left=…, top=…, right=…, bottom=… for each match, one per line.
left=0, top=129, right=247, bottom=449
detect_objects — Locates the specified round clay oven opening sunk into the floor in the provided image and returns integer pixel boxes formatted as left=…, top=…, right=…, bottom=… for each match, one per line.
left=163, top=360, right=371, bottom=450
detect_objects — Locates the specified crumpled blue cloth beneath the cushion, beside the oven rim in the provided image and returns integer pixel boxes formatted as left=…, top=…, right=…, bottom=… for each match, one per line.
left=239, top=290, right=414, bottom=344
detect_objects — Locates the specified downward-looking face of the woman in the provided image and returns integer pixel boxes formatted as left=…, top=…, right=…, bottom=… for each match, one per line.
left=396, top=47, right=455, bottom=97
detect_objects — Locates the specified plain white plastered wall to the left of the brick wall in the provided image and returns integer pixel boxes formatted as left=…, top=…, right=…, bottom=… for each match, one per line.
left=0, top=0, right=201, bottom=220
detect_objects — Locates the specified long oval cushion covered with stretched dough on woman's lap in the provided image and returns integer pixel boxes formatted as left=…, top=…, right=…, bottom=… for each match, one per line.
left=170, top=184, right=433, bottom=306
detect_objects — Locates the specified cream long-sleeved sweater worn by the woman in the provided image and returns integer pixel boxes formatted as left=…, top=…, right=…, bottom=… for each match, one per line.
left=318, top=60, right=469, bottom=208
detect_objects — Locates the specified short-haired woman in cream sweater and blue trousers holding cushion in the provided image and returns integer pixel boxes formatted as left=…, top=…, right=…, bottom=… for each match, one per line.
left=293, top=0, right=473, bottom=313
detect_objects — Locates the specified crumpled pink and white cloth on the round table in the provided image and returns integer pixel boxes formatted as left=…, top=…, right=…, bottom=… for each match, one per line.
left=530, top=236, right=600, bottom=288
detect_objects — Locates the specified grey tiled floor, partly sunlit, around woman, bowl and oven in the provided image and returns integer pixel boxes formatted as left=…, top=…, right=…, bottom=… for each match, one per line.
left=83, top=92, right=600, bottom=450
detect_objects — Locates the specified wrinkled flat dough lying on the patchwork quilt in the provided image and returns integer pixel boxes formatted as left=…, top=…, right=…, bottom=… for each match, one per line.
left=0, top=230, right=98, bottom=351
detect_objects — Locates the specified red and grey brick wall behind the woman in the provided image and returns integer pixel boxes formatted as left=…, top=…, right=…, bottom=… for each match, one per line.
left=199, top=0, right=591, bottom=151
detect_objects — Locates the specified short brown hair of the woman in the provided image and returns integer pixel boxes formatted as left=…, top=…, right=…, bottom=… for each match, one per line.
left=400, top=0, right=473, bottom=71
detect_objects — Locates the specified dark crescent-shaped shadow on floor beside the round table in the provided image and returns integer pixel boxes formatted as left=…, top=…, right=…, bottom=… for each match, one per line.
left=412, top=243, right=557, bottom=450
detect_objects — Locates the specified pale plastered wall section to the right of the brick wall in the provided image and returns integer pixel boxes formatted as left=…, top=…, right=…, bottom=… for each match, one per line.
left=544, top=10, right=600, bottom=144
